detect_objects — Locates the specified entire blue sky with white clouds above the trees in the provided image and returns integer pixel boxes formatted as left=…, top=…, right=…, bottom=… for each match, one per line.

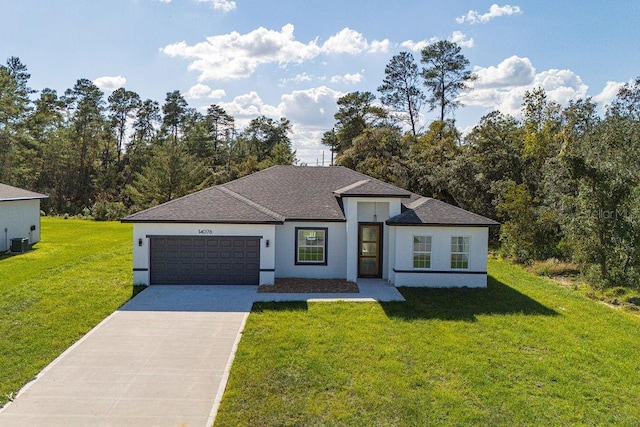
left=0, top=0, right=640, bottom=164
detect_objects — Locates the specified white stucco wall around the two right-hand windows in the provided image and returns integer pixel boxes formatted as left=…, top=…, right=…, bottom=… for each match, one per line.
left=389, top=226, right=489, bottom=287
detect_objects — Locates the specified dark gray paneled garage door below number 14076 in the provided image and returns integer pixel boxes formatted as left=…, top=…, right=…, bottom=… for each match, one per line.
left=150, top=236, right=260, bottom=285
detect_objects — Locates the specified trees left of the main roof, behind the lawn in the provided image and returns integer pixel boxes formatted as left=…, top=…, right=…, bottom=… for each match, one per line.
left=0, top=57, right=295, bottom=219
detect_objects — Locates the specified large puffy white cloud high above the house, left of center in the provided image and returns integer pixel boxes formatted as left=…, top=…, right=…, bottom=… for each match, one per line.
left=161, top=24, right=321, bottom=82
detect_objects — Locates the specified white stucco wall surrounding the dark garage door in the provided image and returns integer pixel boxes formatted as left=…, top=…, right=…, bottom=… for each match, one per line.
left=133, top=223, right=276, bottom=285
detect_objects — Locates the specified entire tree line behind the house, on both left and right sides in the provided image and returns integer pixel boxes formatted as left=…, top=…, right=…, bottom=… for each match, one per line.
left=0, top=41, right=640, bottom=286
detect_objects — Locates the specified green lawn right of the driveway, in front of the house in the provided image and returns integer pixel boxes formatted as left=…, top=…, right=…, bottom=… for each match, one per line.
left=216, top=260, right=640, bottom=426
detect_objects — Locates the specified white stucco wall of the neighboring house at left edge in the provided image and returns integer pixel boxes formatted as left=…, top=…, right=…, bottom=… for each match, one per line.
left=0, top=199, right=40, bottom=251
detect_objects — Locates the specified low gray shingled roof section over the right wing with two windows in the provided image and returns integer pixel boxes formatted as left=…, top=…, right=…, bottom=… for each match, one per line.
left=387, top=197, right=500, bottom=227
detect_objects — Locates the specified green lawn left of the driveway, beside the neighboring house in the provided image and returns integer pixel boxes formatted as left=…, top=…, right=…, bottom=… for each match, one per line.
left=0, top=218, right=132, bottom=406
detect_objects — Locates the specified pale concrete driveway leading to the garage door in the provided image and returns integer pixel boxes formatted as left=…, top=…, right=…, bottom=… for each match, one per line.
left=0, top=286, right=256, bottom=427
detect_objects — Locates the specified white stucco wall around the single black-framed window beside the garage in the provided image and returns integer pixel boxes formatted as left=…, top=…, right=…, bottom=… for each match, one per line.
left=276, top=222, right=347, bottom=279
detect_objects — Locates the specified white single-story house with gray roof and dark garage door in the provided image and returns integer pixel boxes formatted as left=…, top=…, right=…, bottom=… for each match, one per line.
left=122, top=166, right=499, bottom=287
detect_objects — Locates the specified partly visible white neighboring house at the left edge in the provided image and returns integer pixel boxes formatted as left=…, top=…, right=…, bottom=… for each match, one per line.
left=0, top=184, right=49, bottom=252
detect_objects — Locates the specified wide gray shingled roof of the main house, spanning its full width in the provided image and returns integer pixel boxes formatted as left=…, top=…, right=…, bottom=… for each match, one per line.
left=123, top=166, right=497, bottom=225
